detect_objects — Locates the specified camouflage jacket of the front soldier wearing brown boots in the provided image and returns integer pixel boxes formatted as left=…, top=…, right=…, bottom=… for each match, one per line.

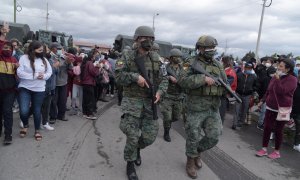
left=178, top=56, right=227, bottom=111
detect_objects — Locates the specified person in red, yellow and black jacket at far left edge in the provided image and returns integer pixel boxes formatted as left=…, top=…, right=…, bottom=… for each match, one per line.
left=0, top=42, right=18, bottom=145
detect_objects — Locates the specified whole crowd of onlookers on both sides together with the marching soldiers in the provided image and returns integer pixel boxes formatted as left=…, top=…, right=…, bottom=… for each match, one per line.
left=0, top=22, right=300, bottom=179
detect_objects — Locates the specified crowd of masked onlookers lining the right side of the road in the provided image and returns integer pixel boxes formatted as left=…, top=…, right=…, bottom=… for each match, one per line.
left=220, top=55, right=300, bottom=159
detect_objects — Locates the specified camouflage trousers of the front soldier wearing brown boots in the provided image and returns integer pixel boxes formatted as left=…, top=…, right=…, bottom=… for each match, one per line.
left=185, top=109, right=222, bottom=157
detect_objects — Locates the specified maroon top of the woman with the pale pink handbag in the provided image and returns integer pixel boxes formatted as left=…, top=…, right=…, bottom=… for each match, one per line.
left=264, top=75, right=297, bottom=110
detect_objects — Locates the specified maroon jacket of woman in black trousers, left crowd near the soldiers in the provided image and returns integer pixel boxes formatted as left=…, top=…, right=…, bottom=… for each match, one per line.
left=81, top=61, right=100, bottom=86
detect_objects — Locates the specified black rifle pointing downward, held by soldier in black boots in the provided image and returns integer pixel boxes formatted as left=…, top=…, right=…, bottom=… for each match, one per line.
left=134, top=55, right=158, bottom=120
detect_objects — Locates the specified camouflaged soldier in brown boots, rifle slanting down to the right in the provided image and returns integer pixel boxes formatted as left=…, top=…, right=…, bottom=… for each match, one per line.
left=178, top=36, right=227, bottom=178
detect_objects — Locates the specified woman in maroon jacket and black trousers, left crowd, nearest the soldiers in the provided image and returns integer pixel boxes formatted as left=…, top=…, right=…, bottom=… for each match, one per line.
left=80, top=49, right=100, bottom=120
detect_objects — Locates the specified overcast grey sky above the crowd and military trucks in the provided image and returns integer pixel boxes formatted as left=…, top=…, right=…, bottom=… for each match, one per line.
left=0, top=0, right=300, bottom=57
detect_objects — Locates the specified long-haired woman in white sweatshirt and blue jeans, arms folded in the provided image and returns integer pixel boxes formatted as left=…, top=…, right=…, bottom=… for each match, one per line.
left=17, top=41, right=52, bottom=141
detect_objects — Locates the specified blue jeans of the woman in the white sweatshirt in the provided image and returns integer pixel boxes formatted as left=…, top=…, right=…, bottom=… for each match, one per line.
left=19, top=88, right=45, bottom=131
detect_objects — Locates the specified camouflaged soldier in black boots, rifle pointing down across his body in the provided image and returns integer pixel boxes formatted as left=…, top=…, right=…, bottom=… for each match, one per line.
left=116, top=26, right=168, bottom=180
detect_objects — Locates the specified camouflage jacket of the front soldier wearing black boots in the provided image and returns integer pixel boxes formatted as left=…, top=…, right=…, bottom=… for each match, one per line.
left=115, top=50, right=168, bottom=117
